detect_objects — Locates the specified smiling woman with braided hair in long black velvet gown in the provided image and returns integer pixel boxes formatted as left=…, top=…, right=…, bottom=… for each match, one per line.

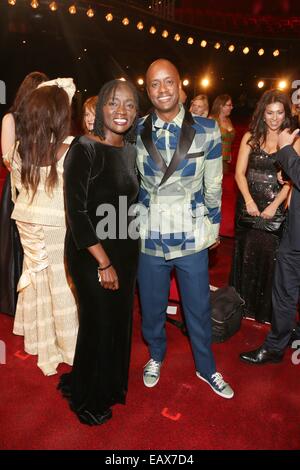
left=59, top=80, right=138, bottom=425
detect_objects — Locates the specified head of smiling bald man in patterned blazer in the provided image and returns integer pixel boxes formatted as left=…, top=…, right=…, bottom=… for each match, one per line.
left=146, top=59, right=181, bottom=121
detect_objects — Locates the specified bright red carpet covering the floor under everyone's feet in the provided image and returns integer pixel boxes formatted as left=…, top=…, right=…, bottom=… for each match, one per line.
left=0, top=240, right=300, bottom=450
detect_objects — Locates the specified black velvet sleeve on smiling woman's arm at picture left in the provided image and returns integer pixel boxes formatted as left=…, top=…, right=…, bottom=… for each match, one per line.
left=64, top=142, right=99, bottom=249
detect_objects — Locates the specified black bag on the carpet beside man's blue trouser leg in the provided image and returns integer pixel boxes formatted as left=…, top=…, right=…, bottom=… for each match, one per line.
left=210, top=286, right=245, bottom=343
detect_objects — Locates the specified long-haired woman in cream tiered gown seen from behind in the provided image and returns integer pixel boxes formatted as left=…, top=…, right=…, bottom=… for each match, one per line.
left=4, top=79, right=78, bottom=375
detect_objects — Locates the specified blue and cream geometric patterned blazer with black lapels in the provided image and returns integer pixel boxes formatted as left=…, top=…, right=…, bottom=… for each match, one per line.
left=137, top=111, right=222, bottom=260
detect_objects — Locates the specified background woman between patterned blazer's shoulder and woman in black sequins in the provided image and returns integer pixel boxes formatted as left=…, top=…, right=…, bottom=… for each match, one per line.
left=209, top=94, right=235, bottom=172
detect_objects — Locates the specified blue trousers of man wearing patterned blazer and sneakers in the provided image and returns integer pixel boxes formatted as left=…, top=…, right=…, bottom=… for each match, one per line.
left=138, top=250, right=216, bottom=377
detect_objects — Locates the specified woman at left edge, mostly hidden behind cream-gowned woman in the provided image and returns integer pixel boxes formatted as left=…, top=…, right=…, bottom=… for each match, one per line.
left=0, top=72, right=48, bottom=315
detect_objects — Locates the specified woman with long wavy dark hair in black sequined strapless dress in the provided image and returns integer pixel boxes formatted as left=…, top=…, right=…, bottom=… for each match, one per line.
left=230, top=90, right=299, bottom=322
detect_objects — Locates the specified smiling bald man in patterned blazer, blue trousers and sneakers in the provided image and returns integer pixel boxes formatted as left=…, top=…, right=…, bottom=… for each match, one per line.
left=137, top=59, right=233, bottom=398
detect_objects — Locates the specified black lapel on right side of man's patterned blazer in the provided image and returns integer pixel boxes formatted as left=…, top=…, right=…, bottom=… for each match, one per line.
left=160, top=111, right=196, bottom=186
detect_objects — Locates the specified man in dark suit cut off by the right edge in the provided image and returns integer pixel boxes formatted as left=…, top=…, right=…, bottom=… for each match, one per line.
left=240, top=129, right=300, bottom=364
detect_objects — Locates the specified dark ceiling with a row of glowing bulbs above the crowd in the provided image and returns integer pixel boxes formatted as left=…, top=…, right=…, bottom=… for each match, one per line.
left=0, top=0, right=300, bottom=112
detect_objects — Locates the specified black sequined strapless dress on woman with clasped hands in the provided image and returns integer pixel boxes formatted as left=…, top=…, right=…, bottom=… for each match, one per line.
left=230, top=149, right=285, bottom=322
